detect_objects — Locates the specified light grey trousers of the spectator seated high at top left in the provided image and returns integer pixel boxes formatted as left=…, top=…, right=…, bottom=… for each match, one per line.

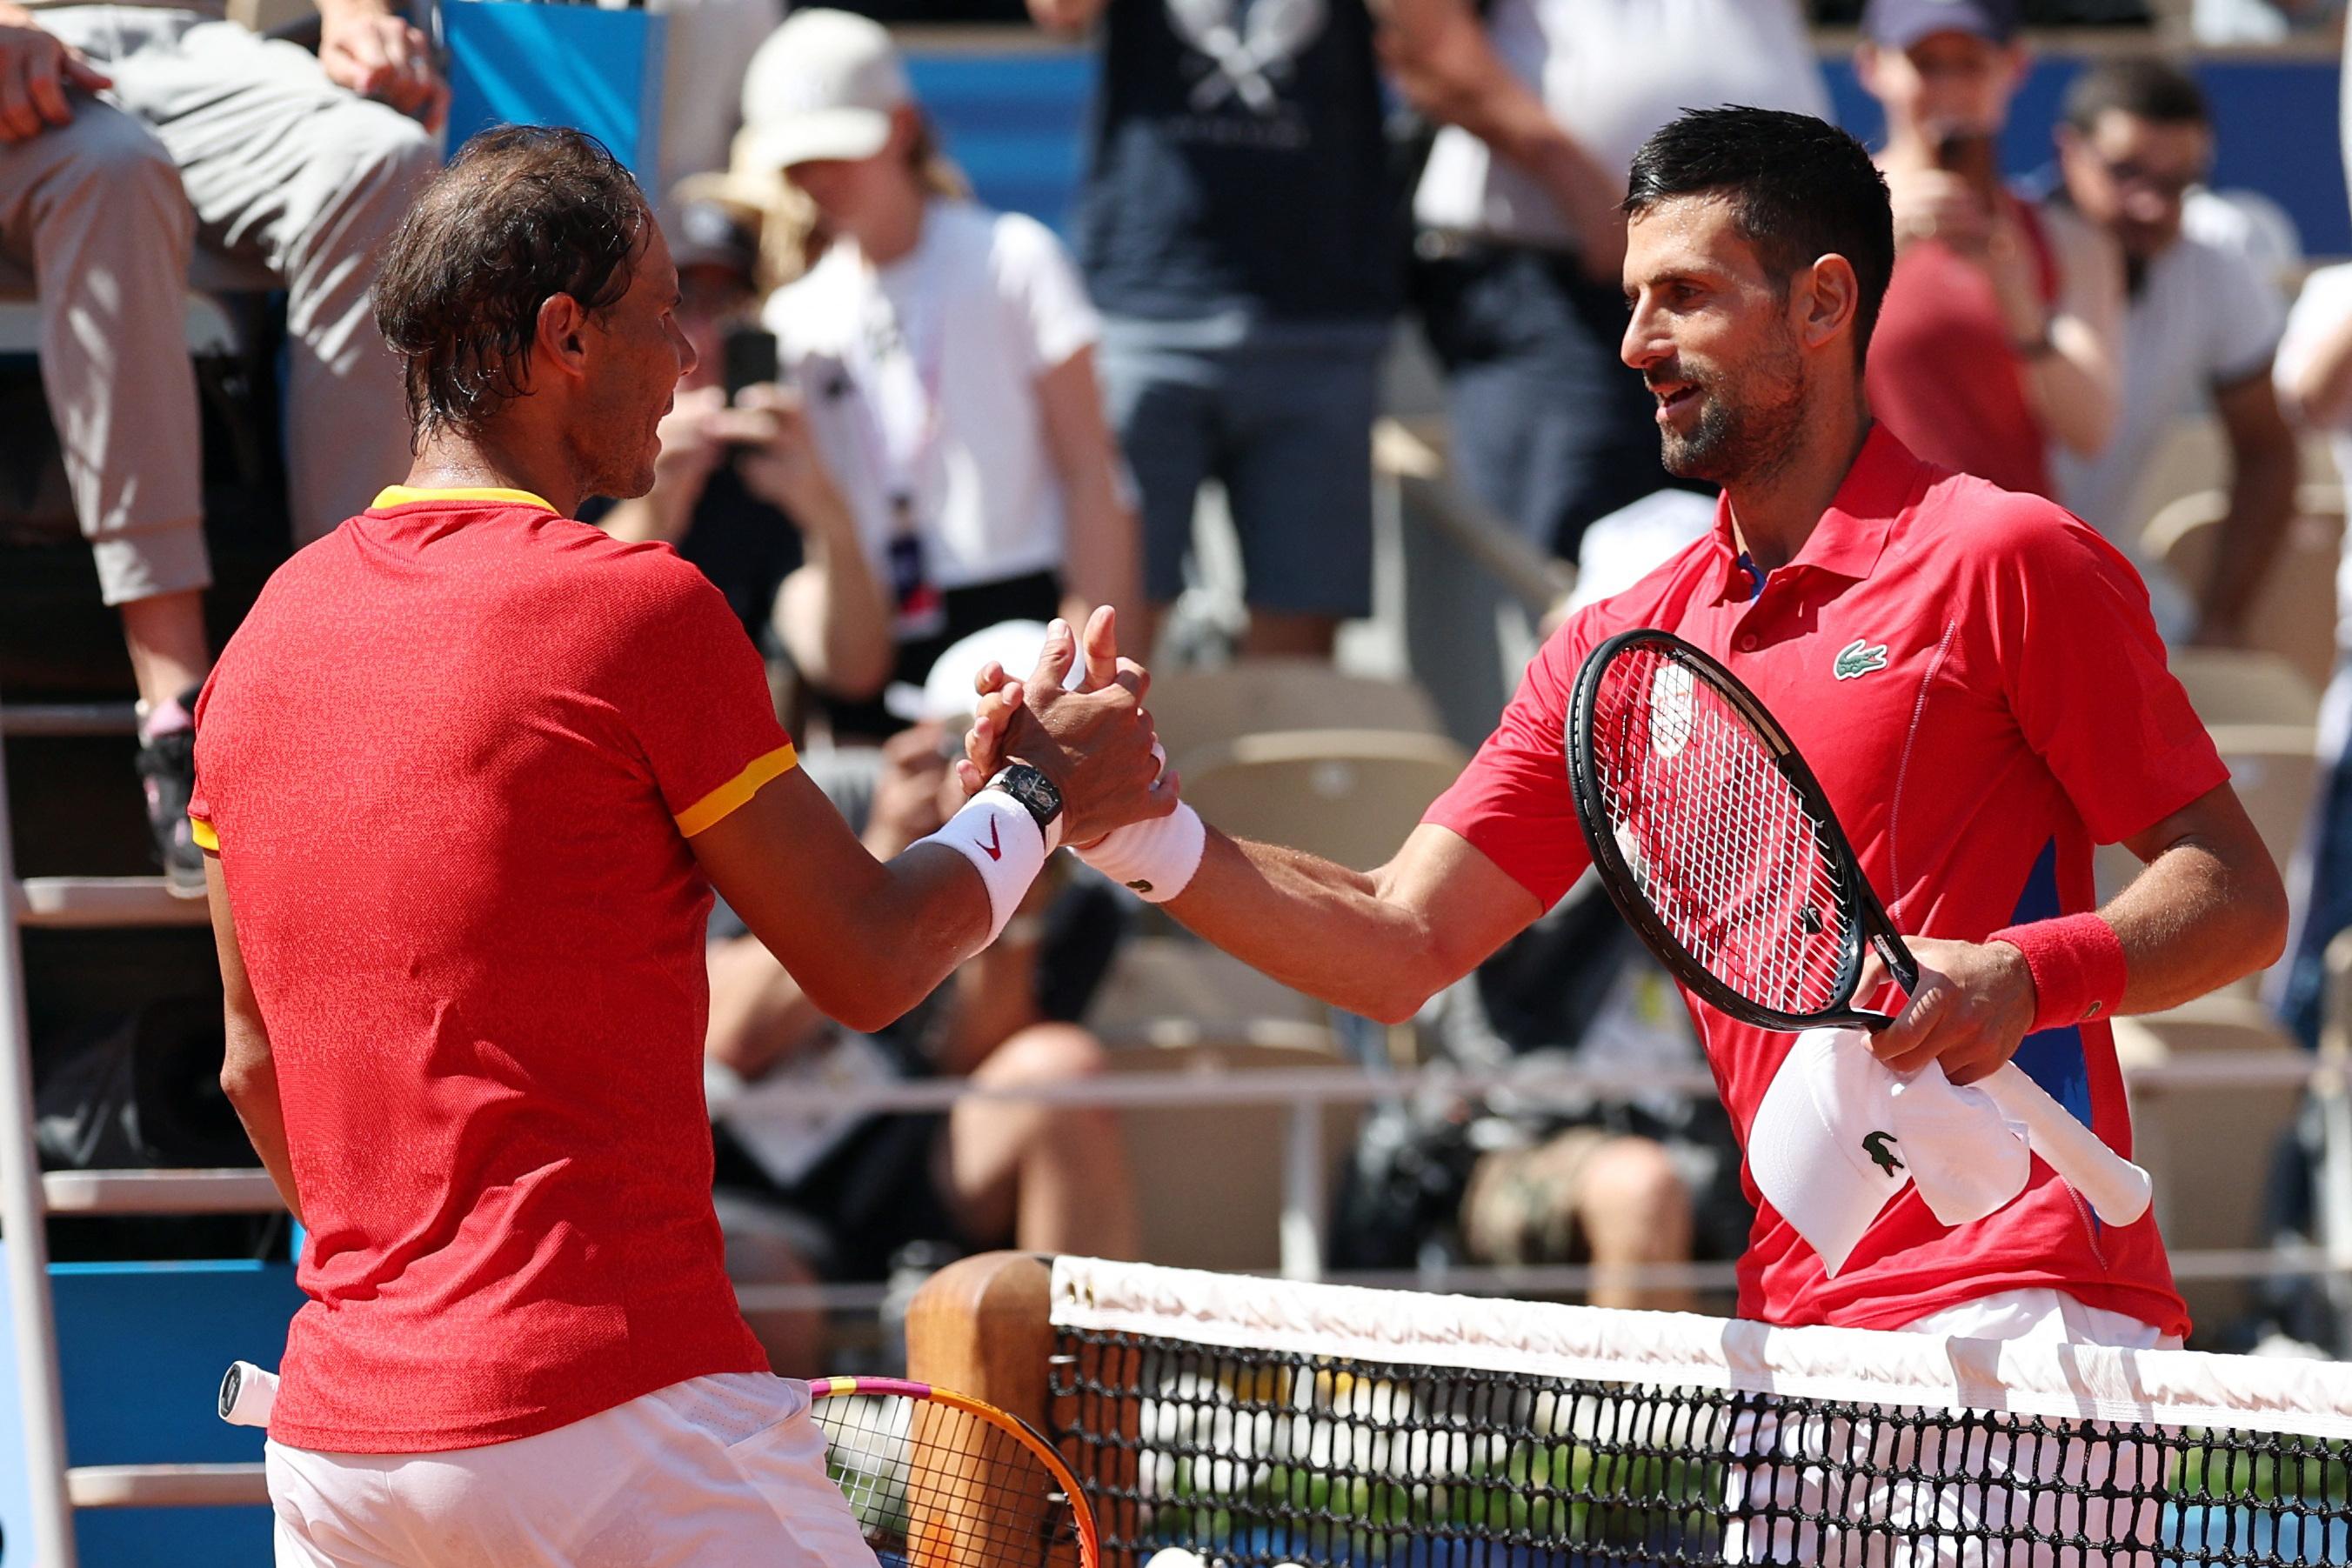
left=0, top=4, right=438, bottom=604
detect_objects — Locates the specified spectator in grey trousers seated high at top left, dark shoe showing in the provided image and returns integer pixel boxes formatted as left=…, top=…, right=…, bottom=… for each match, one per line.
left=0, top=0, right=449, bottom=898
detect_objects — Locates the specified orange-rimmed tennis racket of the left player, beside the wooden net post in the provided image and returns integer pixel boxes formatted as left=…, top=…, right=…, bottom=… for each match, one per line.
left=218, top=1361, right=1100, bottom=1568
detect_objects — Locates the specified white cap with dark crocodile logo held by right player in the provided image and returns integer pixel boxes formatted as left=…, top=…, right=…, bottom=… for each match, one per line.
left=1747, top=1030, right=2032, bottom=1274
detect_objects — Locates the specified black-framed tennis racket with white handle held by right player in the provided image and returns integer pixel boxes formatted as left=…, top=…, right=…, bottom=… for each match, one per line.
left=1567, top=630, right=2149, bottom=1224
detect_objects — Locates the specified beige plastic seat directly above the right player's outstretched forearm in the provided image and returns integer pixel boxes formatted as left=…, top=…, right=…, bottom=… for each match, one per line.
left=1180, top=729, right=1470, bottom=870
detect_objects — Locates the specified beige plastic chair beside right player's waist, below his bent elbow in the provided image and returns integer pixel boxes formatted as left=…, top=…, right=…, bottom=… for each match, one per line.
left=2115, top=994, right=2309, bottom=1324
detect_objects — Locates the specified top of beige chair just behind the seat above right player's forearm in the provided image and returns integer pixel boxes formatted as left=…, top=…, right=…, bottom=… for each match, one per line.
left=1146, top=658, right=1442, bottom=759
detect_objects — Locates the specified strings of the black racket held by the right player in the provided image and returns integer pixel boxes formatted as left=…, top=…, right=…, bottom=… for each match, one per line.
left=1593, top=649, right=1854, bottom=1013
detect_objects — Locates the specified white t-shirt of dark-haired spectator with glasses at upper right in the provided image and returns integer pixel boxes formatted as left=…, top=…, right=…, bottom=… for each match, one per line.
left=2051, top=235, right=2286, bottom=583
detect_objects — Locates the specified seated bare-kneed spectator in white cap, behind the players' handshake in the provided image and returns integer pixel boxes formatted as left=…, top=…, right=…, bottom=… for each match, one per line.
left=705, top=623, right=1139, bottom=1373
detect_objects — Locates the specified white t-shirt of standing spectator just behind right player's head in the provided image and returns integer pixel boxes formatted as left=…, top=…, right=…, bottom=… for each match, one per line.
left=1413, top=0, right=1830, bottom=247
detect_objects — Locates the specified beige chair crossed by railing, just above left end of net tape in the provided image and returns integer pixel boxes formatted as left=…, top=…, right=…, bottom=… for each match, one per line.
left=1108, top=1041, right=1362, bottom=1271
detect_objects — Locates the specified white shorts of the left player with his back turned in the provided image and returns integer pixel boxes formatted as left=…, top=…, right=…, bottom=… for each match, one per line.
left=266, top=1373, right=875, bottom=1568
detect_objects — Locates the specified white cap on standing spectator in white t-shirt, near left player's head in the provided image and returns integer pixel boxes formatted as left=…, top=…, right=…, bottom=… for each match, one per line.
left=736, top=10, right=915, bottom=170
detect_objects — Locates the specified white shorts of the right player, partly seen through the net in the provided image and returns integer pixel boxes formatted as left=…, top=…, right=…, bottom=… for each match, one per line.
left=1724, top=1291, right=2181, bottom=1568
